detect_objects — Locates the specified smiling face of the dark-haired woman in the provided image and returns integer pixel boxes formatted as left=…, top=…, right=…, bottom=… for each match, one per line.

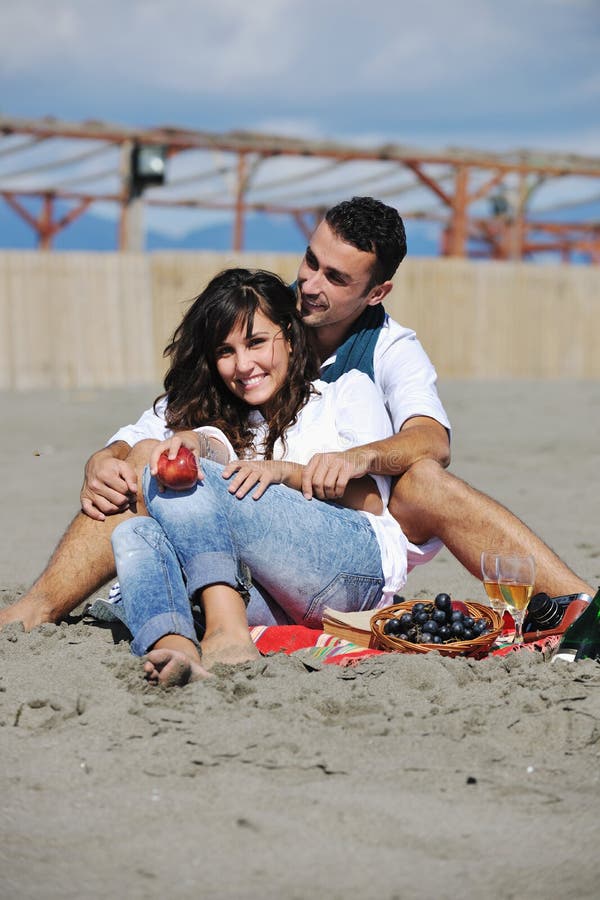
left=215, top=309, right=290, bottom=418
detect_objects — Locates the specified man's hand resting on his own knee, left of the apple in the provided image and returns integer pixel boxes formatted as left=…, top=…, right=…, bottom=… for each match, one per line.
left=80, top=447, right=137, bottom=522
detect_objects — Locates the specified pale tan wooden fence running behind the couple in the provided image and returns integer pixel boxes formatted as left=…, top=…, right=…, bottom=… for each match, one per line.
left=0, top=251, right=600, bottom=390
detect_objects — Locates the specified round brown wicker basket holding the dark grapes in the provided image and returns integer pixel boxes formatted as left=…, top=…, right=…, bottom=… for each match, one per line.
left=370, top=600, right=502, bottom=657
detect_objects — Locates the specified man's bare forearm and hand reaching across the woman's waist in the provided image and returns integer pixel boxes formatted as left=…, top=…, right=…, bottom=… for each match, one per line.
left=302, top=416, right=450, bottom=500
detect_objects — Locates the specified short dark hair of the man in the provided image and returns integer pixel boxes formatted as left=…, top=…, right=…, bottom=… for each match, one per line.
left=325, top=197, right=406, bottom=287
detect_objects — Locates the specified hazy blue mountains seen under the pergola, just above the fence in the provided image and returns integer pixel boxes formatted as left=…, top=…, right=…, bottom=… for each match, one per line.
left=0, top=200, right=439, bottom=256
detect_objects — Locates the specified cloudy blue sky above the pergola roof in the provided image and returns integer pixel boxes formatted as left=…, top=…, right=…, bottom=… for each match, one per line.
left=0, top=0, right=600, bottom=244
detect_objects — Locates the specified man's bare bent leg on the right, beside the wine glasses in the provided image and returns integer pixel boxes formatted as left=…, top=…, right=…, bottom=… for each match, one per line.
left=389, top=460, right=594, bottom=597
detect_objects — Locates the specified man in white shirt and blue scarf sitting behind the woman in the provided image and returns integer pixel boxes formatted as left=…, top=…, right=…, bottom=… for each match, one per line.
left=0, top=197, right=592, bottom=628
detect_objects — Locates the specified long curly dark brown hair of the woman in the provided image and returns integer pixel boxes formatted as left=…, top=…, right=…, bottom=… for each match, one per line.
left=155, top=269, right=319, bottom=459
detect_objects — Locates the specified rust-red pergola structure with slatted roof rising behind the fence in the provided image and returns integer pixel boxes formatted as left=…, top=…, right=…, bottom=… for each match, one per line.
left=0, top=116, right=600, bottom=258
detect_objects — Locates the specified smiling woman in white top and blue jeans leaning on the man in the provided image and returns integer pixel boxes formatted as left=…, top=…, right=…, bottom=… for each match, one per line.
left=113, top=269, right=406, bottom=682
